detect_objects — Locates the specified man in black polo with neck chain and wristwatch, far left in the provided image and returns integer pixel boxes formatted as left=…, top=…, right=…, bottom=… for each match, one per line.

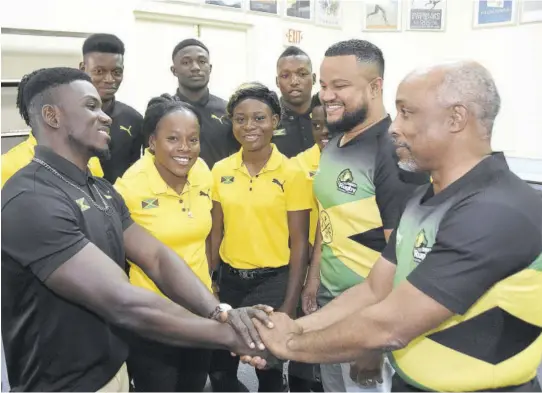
left=2, top=68, right=276, bottom=391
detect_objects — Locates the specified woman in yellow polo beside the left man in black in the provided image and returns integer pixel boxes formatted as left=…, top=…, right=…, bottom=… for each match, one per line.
left=115, top=95, right=212, bottom=392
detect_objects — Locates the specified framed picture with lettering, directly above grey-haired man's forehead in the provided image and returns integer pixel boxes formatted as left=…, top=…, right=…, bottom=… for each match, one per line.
left=407, top=0, right=446, bottom=31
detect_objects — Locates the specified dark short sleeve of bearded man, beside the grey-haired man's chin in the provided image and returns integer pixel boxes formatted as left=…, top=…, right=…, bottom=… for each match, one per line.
left=374, top=140, right=429, bottom=229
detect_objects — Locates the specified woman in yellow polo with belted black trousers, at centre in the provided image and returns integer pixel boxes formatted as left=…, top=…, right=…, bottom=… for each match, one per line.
left=211, top=83, right=312, bottom=392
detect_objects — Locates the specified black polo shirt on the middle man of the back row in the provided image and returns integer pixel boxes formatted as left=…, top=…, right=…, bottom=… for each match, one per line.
left=174, top=89, right=241, bottom=168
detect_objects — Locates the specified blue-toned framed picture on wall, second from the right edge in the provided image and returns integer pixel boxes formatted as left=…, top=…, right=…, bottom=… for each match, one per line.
left=474, top=0, right=517, bottom=28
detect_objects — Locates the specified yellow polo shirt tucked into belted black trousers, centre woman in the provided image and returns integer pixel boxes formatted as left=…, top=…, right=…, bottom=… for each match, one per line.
left=212, top=145, right=312, bottom=269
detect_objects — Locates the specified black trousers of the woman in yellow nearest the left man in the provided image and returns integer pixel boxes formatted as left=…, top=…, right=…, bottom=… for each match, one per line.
left=127, top=337, right=212, bottom=392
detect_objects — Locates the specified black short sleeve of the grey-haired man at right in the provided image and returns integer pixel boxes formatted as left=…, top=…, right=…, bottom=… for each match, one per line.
left=407, top=201, right=542, bottom=314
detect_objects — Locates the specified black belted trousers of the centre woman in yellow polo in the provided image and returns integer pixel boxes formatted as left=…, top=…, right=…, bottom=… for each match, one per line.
left=210, top=264, right=288, bottom=392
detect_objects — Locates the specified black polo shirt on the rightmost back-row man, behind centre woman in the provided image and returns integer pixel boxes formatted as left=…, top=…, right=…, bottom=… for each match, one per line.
left=272, top=100, right=314, bottom=158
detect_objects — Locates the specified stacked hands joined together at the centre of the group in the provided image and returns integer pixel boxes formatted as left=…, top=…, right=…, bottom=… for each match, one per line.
left=220, top=305, right=303, bottom=369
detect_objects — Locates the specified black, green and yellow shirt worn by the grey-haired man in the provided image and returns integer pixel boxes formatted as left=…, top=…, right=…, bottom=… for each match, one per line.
left=382, top=153, right=542, bottom=391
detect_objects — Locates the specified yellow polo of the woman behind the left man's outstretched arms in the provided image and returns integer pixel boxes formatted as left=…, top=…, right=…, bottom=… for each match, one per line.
left=115, top=149, right=213, bottom=296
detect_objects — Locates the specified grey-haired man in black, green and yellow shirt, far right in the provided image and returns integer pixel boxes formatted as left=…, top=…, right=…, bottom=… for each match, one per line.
left=250, top=62, right=542, bottom=392
